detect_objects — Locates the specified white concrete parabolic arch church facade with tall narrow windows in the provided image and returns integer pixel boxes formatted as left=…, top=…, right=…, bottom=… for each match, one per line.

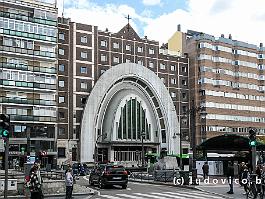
left=80, top=63, right=180, bottom=166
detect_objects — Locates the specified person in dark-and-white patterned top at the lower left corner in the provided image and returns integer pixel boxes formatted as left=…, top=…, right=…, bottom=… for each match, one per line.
left=29, top=165, right=43, bottom=199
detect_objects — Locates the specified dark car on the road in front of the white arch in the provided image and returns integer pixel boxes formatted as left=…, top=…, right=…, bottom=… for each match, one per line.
left=89, top=165, right=128, bottom=189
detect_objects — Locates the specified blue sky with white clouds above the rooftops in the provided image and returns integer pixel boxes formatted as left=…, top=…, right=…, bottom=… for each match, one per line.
left=57, top=0, right=265, bottom=45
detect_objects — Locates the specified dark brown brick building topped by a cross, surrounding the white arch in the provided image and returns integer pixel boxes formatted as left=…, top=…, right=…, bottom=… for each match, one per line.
left=57, top=18, right=190, bottom=164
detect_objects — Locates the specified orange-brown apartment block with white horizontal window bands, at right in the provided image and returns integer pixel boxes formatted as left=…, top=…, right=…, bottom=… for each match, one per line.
left=171, top=30, right=265, bottom=144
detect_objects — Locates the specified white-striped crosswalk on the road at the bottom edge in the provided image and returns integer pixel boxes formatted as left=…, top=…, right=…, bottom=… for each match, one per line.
left=100, top=190, right=223, bottom=199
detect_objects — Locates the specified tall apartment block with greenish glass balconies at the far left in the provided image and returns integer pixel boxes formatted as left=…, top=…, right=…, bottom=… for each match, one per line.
left=0, top=0, right=57, bottom=166
